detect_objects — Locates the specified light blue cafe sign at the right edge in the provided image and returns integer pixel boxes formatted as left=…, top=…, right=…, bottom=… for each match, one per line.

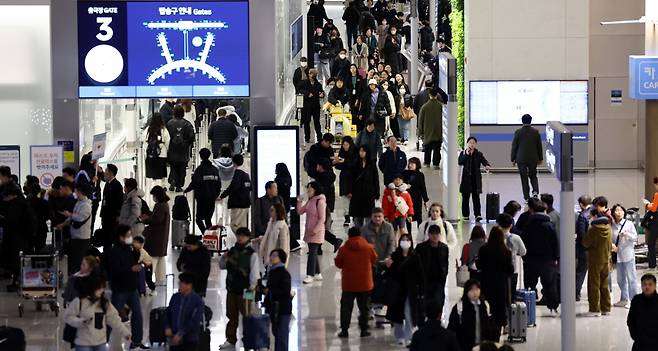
left=628, top=55, right=658, bottom=100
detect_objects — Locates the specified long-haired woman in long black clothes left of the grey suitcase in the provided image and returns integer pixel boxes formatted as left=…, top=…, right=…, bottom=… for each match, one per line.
left=476, top=227, right=514, bottom=330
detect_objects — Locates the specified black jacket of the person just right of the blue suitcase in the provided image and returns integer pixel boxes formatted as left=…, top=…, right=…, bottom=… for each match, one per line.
left=264, top=265, right=292, bottom=318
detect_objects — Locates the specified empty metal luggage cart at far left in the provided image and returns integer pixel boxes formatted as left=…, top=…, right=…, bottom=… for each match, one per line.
left=18, top=251, right=61, bottom=318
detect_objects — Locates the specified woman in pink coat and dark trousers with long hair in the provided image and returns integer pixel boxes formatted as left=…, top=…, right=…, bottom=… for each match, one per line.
left=296, top=181, right=327, bottom=284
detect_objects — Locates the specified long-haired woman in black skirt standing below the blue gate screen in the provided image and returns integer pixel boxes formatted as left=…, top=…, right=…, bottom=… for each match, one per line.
left=143, top=112, right=170, bottom=184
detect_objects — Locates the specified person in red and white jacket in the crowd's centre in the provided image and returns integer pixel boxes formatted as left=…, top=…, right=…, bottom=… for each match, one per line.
left=382, top=175, right=414, bottom=237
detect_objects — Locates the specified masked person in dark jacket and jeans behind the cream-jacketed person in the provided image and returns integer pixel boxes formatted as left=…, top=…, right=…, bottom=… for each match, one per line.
left=103, top=224, right=148, bottom=349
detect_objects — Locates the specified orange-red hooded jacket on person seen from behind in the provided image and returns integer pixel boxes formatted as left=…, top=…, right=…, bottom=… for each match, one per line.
left=334, top=236, right=377, bottom=292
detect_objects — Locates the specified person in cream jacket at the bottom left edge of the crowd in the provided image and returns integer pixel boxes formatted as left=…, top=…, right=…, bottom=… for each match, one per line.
left=64, top=276, right=131, bottom=351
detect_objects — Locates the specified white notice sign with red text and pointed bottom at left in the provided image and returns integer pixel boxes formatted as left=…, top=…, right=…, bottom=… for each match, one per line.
left=30, top=145, right=64, bottom=189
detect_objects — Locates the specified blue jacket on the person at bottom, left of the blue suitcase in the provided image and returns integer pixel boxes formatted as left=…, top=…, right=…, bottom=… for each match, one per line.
left=164, top=292, right=205, bottom=343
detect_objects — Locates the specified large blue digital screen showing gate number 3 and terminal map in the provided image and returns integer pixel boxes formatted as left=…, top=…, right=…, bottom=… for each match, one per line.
left=78, top=0, right=249, bottom=98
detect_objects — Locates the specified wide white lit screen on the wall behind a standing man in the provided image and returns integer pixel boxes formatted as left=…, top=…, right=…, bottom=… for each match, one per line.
left=469, top=80, right=588, bottom=125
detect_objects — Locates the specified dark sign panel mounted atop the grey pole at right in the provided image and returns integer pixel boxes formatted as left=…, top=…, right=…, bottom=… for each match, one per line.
left=545, top=121, right=573, bottom=182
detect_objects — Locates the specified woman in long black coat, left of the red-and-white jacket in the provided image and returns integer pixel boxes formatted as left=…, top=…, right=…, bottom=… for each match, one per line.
left=347, top=145, right=380, bottom=227
